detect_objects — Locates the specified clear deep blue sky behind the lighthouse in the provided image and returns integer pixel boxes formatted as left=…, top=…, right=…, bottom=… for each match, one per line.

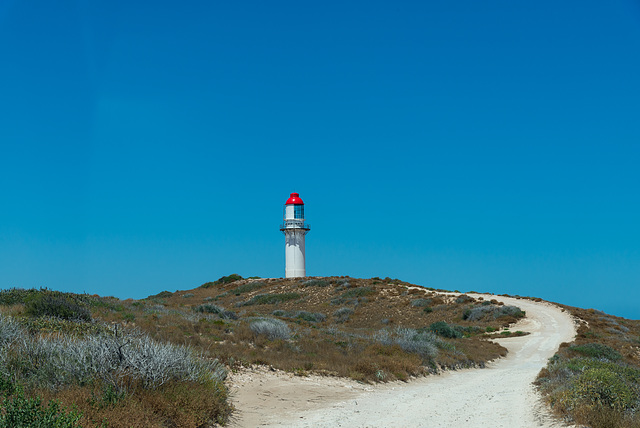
left=0, top=0, right=640, bottom=318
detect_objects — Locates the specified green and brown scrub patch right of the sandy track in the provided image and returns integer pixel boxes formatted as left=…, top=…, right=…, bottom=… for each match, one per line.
left=537, top=306, right=640, bottom=428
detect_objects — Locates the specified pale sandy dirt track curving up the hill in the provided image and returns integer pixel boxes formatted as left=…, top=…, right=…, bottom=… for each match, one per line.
left=231, top=296, right=575, bottom=428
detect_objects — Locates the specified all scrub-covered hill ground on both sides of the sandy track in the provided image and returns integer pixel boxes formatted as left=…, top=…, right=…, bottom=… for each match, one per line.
left=0, top=275, right=640, bottom=427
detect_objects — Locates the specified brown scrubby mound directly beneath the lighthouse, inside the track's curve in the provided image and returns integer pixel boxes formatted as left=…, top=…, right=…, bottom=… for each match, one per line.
left=120, top=275, right=516, bottom=382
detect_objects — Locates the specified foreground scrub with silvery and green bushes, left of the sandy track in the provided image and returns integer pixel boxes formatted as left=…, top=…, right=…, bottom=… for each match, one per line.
left=0, top=289, right=230, bottom=427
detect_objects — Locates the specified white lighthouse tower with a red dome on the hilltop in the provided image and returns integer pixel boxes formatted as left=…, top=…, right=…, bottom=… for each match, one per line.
left=280, top=193, right=310, bottom=278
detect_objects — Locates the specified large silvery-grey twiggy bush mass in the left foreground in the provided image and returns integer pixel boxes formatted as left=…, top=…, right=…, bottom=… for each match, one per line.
left=0, top=319, right=226, bottom=390
